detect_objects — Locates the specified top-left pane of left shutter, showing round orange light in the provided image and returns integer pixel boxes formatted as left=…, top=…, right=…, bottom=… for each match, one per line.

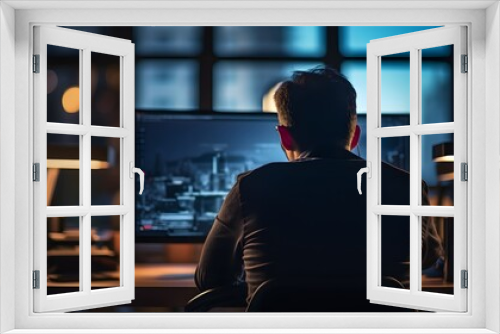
left=47, top=45, right=80, bottom=124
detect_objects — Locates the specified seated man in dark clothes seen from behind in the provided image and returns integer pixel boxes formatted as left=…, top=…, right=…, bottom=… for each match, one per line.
left=195, top=68, right=443, bottom=312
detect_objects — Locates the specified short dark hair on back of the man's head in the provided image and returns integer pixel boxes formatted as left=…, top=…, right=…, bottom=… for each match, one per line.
left=274, top=67, right=356, bottom=150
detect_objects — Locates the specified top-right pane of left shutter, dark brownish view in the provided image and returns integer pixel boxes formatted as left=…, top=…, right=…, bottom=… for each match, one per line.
left=91, top=52, right=120, bottom=127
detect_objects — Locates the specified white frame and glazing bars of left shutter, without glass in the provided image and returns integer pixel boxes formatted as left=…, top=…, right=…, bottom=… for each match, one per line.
left=33, top=26, right=135, bottom=312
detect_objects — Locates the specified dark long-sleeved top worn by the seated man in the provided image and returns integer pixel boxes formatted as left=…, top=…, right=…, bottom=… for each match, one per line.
left=195, top=150, right=442, bottom=308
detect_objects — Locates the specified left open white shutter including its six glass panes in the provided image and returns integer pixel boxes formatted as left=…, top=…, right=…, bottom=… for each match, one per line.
left=33, top=26, right=135, bottom=312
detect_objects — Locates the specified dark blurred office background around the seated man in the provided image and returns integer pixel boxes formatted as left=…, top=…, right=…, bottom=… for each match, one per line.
left=47, top=26, right=453, bottom=312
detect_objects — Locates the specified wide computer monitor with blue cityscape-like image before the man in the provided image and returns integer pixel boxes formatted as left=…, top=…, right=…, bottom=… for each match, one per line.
left=135, top=111, right=409, bottom=242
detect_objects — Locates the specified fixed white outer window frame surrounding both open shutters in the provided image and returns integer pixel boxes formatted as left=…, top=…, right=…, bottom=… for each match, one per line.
left=0, top=1, right=500, bottom=333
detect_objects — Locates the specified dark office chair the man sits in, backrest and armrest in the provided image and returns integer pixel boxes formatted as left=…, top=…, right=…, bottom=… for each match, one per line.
left=185, top=277, right=405, bottom=312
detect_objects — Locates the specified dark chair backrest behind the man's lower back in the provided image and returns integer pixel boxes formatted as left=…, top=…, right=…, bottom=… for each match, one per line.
left=247, top=278, right=405, bottom=312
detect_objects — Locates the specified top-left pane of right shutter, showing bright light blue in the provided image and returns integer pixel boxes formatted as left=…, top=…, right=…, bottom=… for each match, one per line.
left=380, top=52, right=410, bottom=126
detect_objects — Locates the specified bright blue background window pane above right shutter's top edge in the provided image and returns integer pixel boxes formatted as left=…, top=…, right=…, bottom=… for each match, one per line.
left=339, top=26, right=442, bottom=57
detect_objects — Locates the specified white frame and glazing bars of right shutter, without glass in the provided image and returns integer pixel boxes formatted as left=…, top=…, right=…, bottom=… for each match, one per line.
left=367, top=26, right=470, bottom=312
